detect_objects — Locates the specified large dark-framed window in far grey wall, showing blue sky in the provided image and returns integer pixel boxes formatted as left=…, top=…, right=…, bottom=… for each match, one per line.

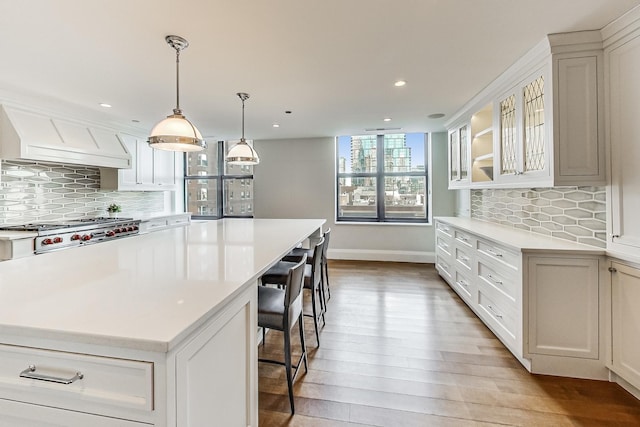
left=336, top=133, right=429, bottom=222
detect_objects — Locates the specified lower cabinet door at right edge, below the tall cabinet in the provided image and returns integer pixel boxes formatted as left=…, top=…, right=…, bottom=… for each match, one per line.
left=611, top=262, right=640, bottom=389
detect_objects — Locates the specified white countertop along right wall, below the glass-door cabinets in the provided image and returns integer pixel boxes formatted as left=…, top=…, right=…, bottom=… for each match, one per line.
left=434, top=217, right=606, bottom=255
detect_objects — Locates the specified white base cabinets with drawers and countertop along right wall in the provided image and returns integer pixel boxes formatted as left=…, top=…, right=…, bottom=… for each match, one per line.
left=436, top=218, right=608, bottom=379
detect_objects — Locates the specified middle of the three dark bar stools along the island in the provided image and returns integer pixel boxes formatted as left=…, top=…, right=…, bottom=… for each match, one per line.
left=261, top=238, right=324, bottom=347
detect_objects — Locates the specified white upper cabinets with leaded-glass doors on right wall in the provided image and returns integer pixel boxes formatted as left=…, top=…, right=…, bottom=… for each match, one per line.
left=447, top=31, right=606, bottom=188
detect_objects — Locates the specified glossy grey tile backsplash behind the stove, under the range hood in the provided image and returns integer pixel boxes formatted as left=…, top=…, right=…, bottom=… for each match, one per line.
left=0, top=160, right=164, bottom=224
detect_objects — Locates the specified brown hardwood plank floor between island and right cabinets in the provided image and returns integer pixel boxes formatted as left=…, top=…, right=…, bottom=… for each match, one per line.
left=259, top=261, right=640, bottom=427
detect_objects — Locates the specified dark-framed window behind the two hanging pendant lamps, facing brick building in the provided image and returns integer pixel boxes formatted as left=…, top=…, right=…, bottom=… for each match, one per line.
left=184, top=141, right=253, bottom=219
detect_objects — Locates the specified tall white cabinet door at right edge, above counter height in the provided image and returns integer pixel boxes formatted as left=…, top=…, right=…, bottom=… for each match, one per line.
left=605, top=23, right=640, bottom=254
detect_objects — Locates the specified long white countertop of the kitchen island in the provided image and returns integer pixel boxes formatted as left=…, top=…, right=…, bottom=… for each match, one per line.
left=0, top=219, right=324, bottom=352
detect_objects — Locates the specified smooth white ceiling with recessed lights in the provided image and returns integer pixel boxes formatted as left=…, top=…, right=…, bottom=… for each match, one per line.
left=0, top=0, right=640, bottom=139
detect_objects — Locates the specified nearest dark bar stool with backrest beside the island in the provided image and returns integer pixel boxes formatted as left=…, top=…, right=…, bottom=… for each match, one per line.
left=258, top=255, right=307, bottom=414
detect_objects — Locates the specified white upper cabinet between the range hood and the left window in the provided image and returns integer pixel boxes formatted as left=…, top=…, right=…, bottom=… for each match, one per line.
left=100, top=134, right=178, bottom=191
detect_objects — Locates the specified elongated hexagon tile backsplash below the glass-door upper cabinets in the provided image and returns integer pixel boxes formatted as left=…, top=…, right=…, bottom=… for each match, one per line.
left=471, top=187, right=607, bottom=248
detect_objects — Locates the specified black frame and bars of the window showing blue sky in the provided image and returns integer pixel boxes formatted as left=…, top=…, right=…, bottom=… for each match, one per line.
left=335, top=132, right=431, bottom=224
